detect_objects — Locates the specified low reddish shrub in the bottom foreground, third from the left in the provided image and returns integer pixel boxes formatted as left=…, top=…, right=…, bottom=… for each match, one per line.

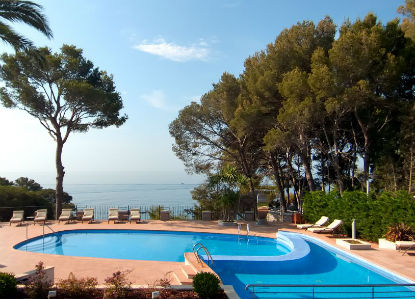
left=57, top=272, right=98, bottom=298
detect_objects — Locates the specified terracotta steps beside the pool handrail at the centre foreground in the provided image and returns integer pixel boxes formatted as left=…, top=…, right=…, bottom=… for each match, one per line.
left=173, top=252, right=216, bottom=285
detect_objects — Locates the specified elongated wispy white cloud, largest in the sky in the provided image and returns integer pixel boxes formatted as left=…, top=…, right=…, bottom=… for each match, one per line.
left=134, top=38, right=209, bottom=62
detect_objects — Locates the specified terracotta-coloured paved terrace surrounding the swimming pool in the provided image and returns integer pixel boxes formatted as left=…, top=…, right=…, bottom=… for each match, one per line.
left=0, top=220, right=415, bottom=285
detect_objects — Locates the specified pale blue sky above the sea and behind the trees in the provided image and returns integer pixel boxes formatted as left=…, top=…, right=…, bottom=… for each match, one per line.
left=0, top=0, right=403, bottom=184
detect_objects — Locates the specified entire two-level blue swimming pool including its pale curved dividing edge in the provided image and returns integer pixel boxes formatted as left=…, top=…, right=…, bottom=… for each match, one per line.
left=14, top=230, right=414, bottom=299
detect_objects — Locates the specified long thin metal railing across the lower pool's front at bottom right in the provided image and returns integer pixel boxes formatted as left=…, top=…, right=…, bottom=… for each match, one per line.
left=245, top=283, right=415, bottom=299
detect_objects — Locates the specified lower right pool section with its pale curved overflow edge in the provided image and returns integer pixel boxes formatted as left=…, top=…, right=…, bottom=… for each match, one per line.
left=212, top=232, right=415, bottom=299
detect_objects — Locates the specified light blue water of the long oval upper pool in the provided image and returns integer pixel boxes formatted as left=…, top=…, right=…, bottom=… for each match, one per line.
left=14, top=230, right=290, bottom=262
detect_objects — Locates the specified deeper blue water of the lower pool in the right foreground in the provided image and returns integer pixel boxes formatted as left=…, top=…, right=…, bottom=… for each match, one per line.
left=212, top=241, right=415, bottom=298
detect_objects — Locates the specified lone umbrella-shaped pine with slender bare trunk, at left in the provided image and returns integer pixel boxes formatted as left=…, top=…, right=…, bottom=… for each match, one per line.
left=0, top=45, right=127, bottom=216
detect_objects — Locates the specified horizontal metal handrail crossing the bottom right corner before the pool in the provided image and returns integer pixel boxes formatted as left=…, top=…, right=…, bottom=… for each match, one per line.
left=245, top=283, right=415, bottom=299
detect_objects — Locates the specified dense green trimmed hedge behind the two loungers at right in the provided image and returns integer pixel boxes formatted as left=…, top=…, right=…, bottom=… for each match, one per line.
left=303, top=191, right=415, bottom=241
